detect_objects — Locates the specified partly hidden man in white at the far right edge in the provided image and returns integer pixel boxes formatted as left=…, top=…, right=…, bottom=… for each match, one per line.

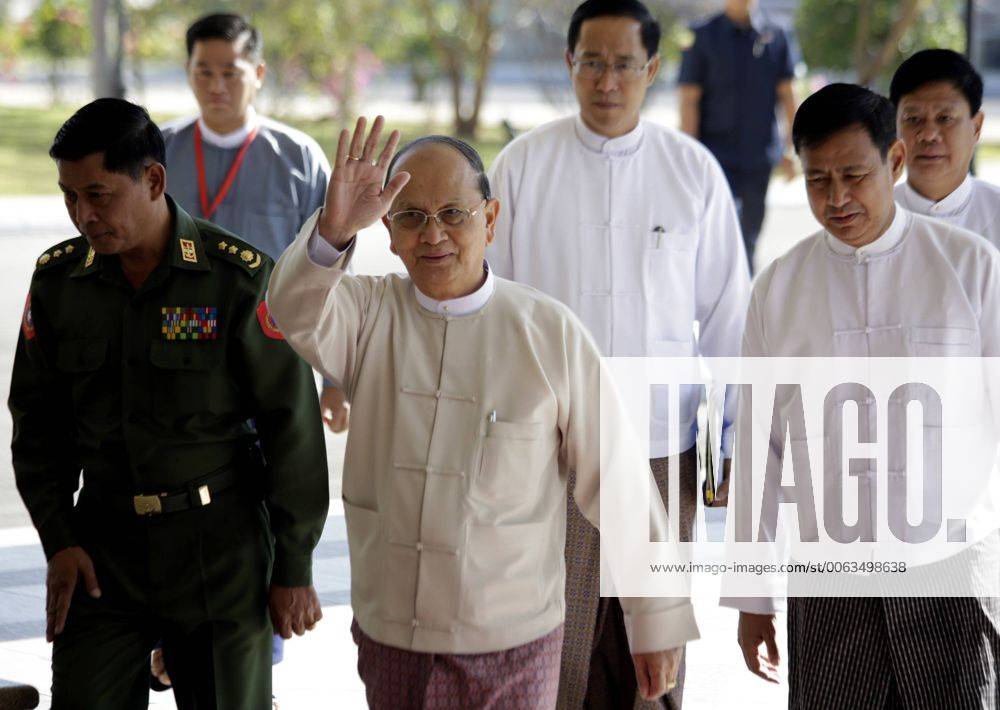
left=889, top=49, right=1000, bottom=246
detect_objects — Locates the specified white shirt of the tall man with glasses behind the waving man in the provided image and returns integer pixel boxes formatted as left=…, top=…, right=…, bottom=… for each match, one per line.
left=487, top=115, right=750, bottom=457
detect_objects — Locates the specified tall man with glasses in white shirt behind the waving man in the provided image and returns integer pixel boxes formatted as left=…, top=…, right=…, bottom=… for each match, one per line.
left=487, top=0, right=750, bottom=708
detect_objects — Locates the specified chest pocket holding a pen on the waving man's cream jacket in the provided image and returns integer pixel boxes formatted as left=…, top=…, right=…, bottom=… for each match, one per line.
left=471, top=421, right=554, bottom=505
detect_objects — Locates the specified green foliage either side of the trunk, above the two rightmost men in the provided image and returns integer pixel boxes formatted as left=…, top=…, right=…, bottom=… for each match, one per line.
left=796, top=0, right=964, bottom=81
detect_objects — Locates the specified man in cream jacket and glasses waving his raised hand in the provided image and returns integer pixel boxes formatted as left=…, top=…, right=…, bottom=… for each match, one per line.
left=268, top=117, right=697, bottom=710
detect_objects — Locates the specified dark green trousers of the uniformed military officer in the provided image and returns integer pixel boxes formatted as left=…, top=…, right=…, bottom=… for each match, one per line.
left=52, top=489, right=272, bottom=710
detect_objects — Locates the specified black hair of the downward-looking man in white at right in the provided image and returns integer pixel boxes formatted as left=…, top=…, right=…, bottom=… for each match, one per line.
left=792, top=84, right=896, bottom=159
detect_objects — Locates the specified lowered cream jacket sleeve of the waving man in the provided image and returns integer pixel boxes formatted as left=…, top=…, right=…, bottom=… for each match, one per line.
left=559, top=312, right=699, bottom=653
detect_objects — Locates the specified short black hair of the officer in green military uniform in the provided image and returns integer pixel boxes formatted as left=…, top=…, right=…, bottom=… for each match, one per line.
left=49, top=99, right=167, bottom=180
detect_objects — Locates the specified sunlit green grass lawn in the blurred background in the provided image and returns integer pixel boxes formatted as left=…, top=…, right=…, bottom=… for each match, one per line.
left=0, top=106, right=507, bottom=196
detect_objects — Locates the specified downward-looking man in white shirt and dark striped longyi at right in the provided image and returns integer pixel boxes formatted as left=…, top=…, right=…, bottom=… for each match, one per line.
left=723, top=84, right=1000, bottom=710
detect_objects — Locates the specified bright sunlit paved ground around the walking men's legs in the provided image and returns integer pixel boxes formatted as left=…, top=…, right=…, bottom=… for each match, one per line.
left=0, top=501, right=786, bottom=710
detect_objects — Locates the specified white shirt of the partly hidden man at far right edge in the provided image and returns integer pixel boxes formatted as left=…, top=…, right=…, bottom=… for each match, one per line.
left=896, top=175, right=1000, bottom=252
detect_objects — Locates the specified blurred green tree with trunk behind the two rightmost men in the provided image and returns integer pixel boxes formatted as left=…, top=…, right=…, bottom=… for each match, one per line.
left=796, top=0, right=964, bottom=85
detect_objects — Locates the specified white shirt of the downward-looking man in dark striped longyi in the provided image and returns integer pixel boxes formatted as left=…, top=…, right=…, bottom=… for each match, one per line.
left=722, top=204, right=1000, bottom=613
